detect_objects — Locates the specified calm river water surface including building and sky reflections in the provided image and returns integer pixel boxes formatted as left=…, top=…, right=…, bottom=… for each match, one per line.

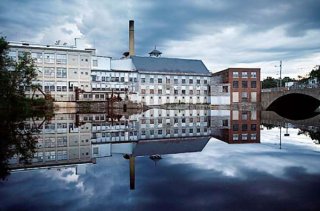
left=0, top=109, right=320, bottom=210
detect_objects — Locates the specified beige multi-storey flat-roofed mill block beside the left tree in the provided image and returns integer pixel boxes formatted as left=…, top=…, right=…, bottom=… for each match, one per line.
left=9, top=42, right=94, bottom=101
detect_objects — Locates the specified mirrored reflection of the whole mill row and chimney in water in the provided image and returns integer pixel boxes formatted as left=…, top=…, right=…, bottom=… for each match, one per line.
left=10, top=109, right=260, bottom=189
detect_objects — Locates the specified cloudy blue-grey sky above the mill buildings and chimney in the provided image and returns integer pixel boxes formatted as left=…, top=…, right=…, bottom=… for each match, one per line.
left=0, top=0, right=320, bottom=77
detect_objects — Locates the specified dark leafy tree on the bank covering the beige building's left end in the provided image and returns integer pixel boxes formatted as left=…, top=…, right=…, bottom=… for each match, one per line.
left=0, top=37, right=37, bottom=109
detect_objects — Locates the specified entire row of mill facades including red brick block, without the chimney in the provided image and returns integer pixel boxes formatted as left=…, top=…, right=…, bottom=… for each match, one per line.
left=9, top=42, right=261, bottom=105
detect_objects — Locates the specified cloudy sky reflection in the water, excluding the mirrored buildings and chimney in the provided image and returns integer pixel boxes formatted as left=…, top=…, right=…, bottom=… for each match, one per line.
left=0, top=128, right=320, bottom=210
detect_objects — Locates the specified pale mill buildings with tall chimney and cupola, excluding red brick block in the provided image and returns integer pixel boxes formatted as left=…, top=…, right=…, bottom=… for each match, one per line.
left=9, top=21, right=211, bottom=105
